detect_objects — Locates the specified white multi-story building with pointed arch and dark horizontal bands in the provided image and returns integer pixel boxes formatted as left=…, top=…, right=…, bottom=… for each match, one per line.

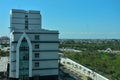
left=9, top=9, right=59, bottom=80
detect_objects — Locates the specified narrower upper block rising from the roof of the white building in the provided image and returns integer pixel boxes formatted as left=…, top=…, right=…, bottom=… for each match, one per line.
left=10, top=10, right=41, bottom=30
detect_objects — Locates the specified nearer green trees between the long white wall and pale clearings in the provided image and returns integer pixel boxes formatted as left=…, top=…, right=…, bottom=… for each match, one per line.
left=64, top=52, right=120, bottom=80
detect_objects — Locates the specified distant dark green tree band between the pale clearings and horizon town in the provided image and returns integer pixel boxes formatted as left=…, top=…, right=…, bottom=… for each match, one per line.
left=60, top=40, right=120, bottom=50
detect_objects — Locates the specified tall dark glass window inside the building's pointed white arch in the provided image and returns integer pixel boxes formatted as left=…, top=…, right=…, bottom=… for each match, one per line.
left=19, top=38, right=29, bottom=80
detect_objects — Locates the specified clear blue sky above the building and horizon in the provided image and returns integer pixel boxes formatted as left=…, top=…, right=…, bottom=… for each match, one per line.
left=0, top=0, right=120, bottom=39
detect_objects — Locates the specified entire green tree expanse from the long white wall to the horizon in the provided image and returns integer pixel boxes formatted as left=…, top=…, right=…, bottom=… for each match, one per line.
left=60, top=41, right=120, bottom=80
